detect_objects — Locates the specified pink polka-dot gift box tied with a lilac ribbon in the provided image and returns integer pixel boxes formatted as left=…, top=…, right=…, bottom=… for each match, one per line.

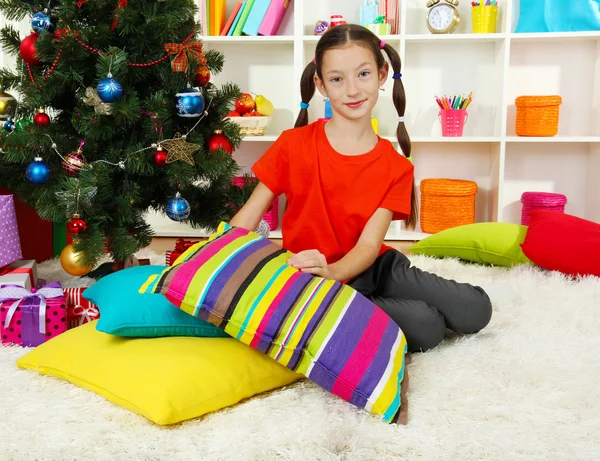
left=0, top=282, right=67, bottom=347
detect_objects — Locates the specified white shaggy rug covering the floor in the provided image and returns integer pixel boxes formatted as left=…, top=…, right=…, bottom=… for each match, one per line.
left=0, top=250, right=600, bottom=461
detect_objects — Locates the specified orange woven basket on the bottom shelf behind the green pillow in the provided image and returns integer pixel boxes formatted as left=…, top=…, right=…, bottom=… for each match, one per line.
left=420, top=178, right=478, bottom=234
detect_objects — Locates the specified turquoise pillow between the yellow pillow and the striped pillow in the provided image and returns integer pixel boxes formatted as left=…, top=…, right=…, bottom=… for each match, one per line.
left=82, top=266, right=229, bottom=338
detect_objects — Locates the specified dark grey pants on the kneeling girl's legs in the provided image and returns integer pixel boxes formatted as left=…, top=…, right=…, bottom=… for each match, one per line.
left=348, top=250, right=492, bottom=352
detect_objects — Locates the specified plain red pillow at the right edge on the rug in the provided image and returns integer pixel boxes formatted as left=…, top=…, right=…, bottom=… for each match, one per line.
left=521, top=210, right=600, bottom=277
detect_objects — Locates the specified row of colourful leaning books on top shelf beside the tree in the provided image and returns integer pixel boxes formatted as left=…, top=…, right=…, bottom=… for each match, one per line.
left=199, top=0, right=291, bottom=36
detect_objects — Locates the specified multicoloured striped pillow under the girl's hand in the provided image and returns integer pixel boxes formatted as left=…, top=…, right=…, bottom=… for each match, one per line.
left=140, top=224, right=407, bottom=422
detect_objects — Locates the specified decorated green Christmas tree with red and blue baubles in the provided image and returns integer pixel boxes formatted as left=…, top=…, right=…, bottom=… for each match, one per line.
left=0, top=0, right=246, bottom=275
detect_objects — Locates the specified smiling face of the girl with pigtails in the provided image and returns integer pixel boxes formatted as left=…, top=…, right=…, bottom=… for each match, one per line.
left=315, top=44, right=388, bottom=120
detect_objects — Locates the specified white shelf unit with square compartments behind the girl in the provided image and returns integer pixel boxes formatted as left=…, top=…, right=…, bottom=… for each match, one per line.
left=142, top=0, right=600, bottom=240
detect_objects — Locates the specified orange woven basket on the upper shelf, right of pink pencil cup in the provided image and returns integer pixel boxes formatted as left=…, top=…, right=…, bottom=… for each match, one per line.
left=515, top=96, right=562, bottom=137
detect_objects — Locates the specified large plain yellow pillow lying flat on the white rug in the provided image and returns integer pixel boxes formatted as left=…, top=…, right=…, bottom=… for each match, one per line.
left=17, top=321, right=303, bottom=425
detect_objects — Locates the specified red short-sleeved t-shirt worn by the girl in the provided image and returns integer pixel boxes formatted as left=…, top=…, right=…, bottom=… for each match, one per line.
left=252, top=122, right=414, bottom=264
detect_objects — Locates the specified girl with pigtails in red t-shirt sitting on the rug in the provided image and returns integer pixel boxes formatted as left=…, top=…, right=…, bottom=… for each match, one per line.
left=230, top=24, right=492, bottom=352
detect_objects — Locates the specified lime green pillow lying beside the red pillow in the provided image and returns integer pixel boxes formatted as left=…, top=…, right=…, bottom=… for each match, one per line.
left=409, top=222, right=531, bottom=267
